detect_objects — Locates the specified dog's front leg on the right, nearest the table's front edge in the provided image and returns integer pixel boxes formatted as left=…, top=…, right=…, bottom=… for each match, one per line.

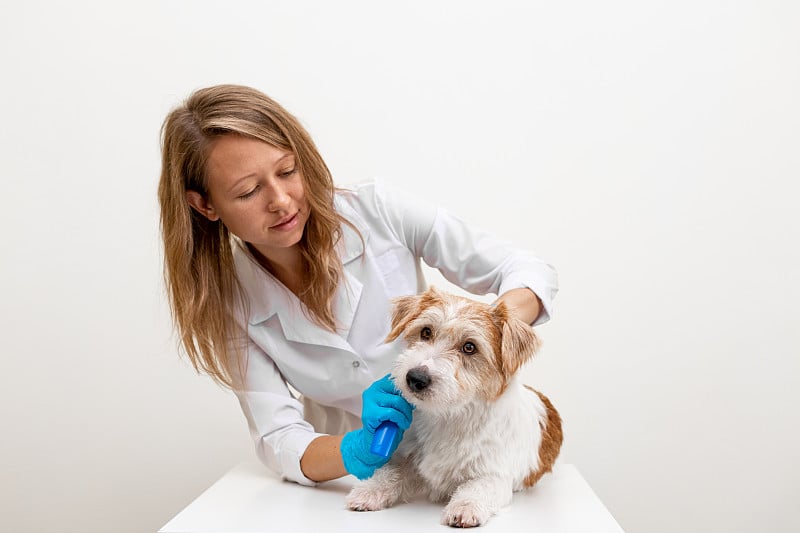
left=442, top=478, right=512, bottom=527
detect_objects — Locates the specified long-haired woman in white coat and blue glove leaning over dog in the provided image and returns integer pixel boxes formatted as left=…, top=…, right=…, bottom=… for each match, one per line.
left=159, top=85, right=557, bottom=485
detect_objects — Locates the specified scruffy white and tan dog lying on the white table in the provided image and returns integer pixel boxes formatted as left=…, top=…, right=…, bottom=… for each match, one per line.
left=346, top=288, right=563, bottom=527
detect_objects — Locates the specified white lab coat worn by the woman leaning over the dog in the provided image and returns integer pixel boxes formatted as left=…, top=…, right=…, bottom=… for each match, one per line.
left=234, top=182, right=557, bottom=485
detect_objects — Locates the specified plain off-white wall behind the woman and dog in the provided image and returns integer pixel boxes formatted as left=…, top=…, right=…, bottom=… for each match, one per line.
left=0, top=0, right=800, bottom=533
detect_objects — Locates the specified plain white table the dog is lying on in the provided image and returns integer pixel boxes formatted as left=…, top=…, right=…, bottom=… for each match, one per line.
left=159, top=462, right=622, bottom=533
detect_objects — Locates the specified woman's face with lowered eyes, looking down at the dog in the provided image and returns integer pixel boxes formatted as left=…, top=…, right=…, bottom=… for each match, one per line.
left=187, top=134, right=309, bottom=260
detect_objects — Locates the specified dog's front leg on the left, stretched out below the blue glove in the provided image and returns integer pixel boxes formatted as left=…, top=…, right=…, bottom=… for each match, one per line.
left=345, top=459, right=419, bottom=511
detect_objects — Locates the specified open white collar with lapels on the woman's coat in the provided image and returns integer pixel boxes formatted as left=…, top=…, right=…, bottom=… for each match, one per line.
left=234, top=196, right=369, bottom=350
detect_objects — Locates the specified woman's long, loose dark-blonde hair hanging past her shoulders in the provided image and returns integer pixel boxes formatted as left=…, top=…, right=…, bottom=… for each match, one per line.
left=158, top=85, right=355, bottom=387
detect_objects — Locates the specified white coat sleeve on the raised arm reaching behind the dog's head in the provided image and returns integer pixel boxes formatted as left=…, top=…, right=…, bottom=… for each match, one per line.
left=375, top=182, right=558, bottom=325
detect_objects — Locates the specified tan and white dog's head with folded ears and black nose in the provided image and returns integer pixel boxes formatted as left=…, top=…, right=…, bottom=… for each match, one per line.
left=386, top=288, right=539, bottom=411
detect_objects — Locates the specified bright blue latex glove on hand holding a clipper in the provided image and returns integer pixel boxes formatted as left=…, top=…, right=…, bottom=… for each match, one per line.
left=340, top=374, right=413, bottom=479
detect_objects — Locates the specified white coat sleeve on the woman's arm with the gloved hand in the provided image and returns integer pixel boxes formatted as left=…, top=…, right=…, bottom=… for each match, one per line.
left=234, top=342, right=322, bottom=486
